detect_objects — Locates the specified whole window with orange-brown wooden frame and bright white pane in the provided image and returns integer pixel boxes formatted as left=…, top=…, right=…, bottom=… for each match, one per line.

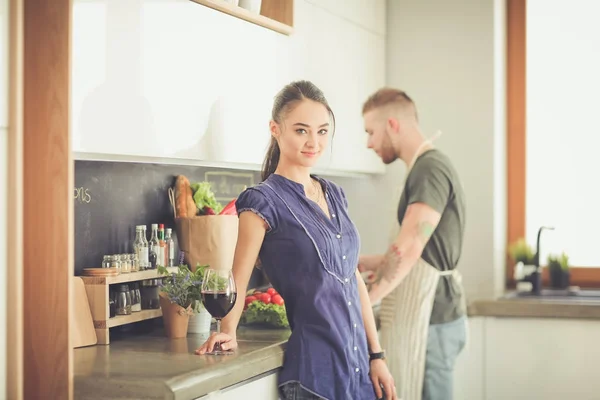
left=507, top=0, right=600, bottom=286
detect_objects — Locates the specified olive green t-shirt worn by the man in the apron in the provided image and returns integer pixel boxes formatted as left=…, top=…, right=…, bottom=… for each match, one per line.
left=398, top=149, right=466, bottom=324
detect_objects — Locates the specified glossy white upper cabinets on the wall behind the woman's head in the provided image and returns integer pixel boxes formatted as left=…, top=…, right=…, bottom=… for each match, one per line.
left=72, top=0, right=385, bottom=174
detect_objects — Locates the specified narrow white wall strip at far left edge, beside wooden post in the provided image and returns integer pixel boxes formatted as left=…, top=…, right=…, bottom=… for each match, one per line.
left=0, top=0, right=9, bottom=398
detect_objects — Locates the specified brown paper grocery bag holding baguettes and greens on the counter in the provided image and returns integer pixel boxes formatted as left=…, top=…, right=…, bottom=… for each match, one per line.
left=169, top=189, right=238, bottom=271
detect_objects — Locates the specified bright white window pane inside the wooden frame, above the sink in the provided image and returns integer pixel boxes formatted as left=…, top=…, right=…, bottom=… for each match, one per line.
left=525, top=0, right=600, bottom=267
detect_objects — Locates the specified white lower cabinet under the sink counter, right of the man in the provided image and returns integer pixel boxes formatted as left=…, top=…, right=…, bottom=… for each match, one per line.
left=484, top=317, right=600, bottom=400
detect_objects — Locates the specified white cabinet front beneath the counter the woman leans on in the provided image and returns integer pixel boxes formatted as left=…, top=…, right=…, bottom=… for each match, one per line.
left=198, top=372, right=279, bottom=400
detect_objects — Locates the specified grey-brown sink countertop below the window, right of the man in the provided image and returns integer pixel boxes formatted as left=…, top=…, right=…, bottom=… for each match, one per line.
left=467, top=297, right=600, bottom=319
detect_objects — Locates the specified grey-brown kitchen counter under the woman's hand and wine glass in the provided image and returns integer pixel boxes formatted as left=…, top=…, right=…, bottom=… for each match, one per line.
left=73, top=328, right=290, bottom=400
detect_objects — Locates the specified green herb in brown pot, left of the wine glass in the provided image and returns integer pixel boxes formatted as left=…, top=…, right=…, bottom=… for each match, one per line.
left=158, top=264, right=194, bottom=339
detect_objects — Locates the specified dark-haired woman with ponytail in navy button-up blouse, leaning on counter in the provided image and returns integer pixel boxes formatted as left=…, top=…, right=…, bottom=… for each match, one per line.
left=196, top=81, right=397, bottom=400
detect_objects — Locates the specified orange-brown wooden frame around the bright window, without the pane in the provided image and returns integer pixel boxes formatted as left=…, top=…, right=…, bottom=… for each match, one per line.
left=506, top=0, right=600, bottom=288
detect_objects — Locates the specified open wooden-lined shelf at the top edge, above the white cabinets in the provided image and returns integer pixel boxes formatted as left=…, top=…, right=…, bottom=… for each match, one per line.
left=190, top=0, right=294, bottom=35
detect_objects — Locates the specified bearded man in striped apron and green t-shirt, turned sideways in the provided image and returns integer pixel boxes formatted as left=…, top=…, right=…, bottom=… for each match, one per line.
left=359, top=88, right=467, bottom=400
